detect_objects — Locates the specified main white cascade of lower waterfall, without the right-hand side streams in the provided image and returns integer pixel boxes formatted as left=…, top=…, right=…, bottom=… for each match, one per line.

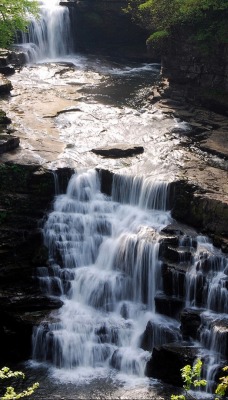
left=33, top=171, right=178, bottom=376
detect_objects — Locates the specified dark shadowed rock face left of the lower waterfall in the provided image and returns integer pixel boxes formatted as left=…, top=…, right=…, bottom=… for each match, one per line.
left=0, top=164, right=72, bottom=361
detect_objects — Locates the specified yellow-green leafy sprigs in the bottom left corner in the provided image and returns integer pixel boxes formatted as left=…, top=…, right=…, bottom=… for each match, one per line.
left=0, top=367, right=39, bottom=400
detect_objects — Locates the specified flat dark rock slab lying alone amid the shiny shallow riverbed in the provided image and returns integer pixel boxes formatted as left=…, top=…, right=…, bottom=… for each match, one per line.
left=91, top=143, right=144, bottom=158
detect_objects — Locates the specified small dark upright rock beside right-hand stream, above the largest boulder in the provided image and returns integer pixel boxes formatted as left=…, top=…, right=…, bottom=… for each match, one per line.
left=180, top=309, right=201, bottom=340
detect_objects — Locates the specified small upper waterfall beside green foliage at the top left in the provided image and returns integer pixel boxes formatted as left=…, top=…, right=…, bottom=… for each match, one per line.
left=19, top=0, right=72, bottom=62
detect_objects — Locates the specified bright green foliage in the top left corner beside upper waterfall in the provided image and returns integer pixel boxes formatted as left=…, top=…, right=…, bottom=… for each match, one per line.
left=0, top=0, right=38, bottom=48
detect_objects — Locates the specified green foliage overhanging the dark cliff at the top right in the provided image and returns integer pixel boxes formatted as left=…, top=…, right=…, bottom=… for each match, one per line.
left=125, top=0, right=228, bottom=49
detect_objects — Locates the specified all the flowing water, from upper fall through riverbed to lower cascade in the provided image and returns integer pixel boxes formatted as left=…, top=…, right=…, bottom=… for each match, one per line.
left=9, top=1, right=228, bottom=400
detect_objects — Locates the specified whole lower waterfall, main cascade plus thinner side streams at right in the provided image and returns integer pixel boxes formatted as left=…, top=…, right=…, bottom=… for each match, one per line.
left=33, top=170, right=228, bottom=391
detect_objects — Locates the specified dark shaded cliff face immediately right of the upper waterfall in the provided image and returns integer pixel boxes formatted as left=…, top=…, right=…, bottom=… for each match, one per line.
left=60, top=0, right=153, bottom=59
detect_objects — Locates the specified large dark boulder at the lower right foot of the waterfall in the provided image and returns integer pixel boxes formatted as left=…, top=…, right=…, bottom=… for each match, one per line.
left=145, top=342, right=199, bottom=386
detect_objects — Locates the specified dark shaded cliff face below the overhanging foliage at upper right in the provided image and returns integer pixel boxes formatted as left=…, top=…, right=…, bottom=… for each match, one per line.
left=161, top=27, right=228, bottom=115
